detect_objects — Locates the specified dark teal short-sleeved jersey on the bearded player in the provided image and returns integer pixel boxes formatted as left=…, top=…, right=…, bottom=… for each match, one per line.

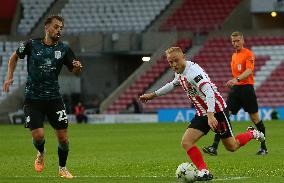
left=16, top=39, right=75, bottom=100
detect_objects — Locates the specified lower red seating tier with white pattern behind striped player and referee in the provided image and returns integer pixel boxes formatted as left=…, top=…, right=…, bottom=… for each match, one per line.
left=140, top=37, right=284, bottom=112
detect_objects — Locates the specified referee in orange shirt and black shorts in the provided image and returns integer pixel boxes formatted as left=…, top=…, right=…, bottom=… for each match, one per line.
left=203, top=31, right=268, bottom=155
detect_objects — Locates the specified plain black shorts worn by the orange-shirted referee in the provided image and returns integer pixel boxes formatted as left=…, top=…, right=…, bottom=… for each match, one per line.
left=227, top=85, right=258, bottom=115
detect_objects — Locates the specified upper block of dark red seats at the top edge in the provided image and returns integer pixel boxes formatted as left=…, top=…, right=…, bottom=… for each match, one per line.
left=160, top=0, right=240, bottom=33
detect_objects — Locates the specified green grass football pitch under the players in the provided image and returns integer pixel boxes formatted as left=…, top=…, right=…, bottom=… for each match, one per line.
left=0, top=121, right=284, bottom=183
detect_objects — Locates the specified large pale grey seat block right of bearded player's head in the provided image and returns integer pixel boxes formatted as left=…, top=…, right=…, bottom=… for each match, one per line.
left=61, top=0, right=170, bottom=34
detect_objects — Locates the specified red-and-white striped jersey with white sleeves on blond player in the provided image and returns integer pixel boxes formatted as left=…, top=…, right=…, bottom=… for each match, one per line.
left=155, top=61, right=227, bottom=116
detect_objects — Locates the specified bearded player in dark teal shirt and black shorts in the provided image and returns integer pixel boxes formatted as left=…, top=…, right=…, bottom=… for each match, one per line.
left=3, top=15, right=82, bottom=179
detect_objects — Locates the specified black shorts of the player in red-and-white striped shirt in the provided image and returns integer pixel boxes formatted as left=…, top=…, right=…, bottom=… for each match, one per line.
left=188, top=109, right=234, bottom=139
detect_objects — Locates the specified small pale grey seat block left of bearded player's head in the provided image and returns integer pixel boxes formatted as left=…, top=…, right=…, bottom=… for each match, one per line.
left=18, top=0, right=54, bottom=35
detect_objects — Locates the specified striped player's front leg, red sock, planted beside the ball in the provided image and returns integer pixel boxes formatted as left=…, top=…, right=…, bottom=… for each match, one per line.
left=181, top=128, right=213, bottom=181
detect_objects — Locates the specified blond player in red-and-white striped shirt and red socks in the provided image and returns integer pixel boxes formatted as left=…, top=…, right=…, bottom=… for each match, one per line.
left=140, top=47, right=265, bottom=181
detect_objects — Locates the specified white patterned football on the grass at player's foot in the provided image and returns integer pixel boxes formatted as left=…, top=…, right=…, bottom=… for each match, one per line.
left=176, top=162, right=198, bottom=183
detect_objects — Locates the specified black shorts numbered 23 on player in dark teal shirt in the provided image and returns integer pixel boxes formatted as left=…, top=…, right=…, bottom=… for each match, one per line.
left=24, top=98, right=68, bottom=130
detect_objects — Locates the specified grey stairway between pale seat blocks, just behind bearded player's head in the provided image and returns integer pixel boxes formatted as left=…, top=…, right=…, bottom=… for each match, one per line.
left=31, top=0, right=68, bottom=36
